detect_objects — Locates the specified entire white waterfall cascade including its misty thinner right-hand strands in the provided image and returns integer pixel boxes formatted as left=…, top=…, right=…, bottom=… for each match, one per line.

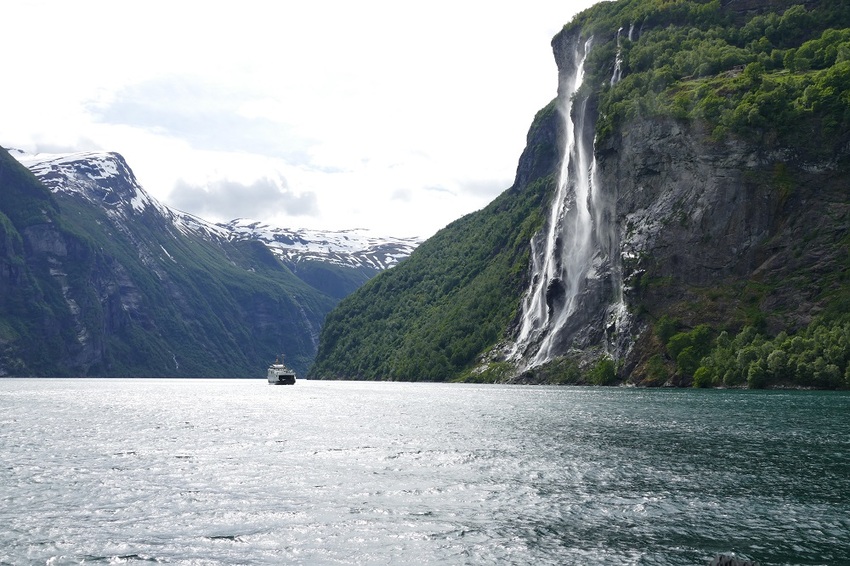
left=511, top=38, right=625, bottom=369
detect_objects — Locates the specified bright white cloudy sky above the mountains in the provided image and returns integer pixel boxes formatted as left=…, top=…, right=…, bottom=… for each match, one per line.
left=0, top=0, right=598, bottom=238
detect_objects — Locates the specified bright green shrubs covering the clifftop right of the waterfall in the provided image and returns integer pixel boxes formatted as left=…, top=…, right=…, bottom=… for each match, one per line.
left=572, top=0, right=850, bottom=154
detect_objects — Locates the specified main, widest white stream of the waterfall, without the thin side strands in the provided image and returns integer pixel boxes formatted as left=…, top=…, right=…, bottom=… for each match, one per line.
left=514, top=38, right=594, bottom=367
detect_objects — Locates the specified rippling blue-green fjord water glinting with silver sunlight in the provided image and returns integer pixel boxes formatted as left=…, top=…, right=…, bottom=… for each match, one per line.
left=0, top=379, right=850, bottom=565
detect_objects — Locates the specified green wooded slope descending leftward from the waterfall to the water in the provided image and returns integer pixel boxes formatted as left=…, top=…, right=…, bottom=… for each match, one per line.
left=310, top=105, right=557, bottom=381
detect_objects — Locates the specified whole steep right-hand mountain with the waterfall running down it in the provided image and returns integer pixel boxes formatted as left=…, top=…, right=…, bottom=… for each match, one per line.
left=311, top=0, right=850, bottom=387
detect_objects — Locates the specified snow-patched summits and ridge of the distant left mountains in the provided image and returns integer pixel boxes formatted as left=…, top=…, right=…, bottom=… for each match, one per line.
left=9, top=149, right=421, bottom=271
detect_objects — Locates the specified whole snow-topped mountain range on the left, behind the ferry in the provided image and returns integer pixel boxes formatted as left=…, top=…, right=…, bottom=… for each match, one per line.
left=0, top=150, right=416, bottom=377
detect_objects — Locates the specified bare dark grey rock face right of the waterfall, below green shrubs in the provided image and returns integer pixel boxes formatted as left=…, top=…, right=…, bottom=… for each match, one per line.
left=598, top=119, right=850, bottom=380
